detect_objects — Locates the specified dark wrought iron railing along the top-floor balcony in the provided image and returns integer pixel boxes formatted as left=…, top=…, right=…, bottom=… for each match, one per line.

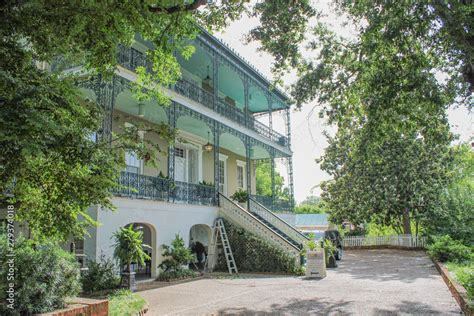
left=118, top=46, right=289, bottom=147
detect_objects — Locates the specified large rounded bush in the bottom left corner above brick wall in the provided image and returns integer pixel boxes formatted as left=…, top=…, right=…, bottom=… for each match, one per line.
left=0, top=234, right=81, bottom=315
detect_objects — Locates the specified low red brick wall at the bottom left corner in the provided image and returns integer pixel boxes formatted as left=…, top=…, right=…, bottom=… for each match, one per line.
left=38, top=297, right=109, bottom=316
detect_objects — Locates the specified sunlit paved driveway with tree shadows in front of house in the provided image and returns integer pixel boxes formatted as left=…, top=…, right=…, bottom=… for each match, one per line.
left=140, top=250, right=461, bottom=315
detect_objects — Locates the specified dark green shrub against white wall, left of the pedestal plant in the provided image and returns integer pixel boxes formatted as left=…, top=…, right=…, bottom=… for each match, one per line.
left=81, top=256, right=120, bottom=292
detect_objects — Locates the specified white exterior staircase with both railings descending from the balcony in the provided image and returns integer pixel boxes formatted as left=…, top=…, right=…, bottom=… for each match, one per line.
left=219, top=193, right=308, bottom=265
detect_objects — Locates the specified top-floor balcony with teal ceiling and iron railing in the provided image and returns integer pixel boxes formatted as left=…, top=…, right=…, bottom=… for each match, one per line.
left=118, top=34, right=290, bottom=149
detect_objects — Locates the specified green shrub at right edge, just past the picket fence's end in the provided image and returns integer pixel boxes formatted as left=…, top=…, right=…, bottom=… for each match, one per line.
left=428, top=235, right=472, bottom=263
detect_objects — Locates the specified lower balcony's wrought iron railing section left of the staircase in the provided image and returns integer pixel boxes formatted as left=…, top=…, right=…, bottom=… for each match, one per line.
left=113, top=171, right=216, bottom=205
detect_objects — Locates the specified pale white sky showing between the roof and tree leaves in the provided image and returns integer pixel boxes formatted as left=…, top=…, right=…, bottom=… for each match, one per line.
left=215, top=6, right=474, bottom=202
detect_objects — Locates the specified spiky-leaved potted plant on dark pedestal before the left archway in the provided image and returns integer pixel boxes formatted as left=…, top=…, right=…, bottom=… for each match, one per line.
left=112, top=225, right=150, bottom=291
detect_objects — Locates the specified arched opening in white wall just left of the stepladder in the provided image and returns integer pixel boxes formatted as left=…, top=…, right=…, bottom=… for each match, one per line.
left=189, top=224, right=211, bottom=271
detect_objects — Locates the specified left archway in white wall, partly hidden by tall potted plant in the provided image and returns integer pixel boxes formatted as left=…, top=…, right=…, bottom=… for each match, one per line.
left=125, top=223, right=157, bottom=279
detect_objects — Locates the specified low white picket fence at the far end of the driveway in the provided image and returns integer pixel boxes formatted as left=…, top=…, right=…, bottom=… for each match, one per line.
left=343, top=235, right=426, bottom=248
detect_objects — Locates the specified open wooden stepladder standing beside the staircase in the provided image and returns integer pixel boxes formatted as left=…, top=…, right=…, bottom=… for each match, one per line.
left=206, top=218, right=239, bottom=274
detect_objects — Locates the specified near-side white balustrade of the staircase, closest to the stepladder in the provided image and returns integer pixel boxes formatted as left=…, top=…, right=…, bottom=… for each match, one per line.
left=219, top=193, right=300, bottom=264
